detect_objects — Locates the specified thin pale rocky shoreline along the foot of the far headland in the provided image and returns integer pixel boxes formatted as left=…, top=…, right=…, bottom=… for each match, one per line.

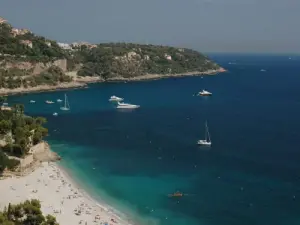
left=0, top=67, right=227, bottom=96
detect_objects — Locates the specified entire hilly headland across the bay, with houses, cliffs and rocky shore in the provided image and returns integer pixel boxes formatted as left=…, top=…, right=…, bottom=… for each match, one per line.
left=0, top=16, right=223, bottom=94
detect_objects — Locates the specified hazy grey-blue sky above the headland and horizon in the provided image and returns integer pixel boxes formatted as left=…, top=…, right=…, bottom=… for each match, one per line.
left=0, top=0, right=300, bottom=52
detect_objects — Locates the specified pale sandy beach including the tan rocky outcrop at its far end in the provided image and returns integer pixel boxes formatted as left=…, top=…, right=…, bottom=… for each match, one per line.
left=0, top=141, right=137, bottom=225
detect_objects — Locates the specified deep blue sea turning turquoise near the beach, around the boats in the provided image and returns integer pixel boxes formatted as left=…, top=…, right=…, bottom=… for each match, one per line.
left=8, top=54, right=300, bottom=225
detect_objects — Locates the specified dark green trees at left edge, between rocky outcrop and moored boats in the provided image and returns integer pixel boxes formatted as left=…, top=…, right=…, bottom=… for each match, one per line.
left=0, top=97, right=48, bottom=174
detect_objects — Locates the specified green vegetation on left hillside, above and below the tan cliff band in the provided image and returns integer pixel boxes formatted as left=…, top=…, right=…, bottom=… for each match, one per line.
left=0, top=23, right=72, bottom=89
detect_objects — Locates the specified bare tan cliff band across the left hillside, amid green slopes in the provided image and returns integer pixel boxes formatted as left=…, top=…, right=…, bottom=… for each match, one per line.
left=0, top=59, right=67, bottom=75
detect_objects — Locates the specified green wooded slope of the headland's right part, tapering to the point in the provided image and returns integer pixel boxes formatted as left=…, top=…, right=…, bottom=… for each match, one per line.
left=73, top=43, right=220, bottom=79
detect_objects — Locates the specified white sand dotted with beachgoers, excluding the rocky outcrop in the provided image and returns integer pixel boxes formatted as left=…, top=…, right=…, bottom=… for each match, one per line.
left=0, top=163, right=134, bottom=225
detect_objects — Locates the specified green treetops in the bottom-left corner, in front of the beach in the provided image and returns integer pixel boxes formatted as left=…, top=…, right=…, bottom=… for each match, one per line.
left=0, top=199, right=59, bottom=225
